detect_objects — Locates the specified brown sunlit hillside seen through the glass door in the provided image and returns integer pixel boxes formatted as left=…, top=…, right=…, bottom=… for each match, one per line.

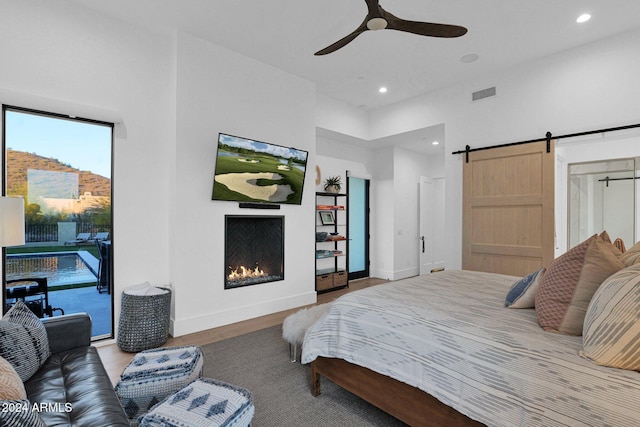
left=7, top=148, right=111, bottom=197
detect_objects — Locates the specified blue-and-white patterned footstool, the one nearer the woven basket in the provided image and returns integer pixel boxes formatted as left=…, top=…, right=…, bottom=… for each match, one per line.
left=115, top=346, right=203, bottom=426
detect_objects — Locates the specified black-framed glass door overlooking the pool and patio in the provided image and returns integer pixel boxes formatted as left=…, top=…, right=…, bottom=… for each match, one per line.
left=2, top=106, right=113, bottom=338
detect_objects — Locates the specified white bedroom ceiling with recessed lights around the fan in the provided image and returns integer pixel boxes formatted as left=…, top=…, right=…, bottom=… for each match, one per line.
left=71, top=0, right=640, bottom=110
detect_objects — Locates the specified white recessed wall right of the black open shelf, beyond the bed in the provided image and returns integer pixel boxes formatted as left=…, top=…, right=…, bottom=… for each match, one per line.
left=316, top=131, right=444, bottom=279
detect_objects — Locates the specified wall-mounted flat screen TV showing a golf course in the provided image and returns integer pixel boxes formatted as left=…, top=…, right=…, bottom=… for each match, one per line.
left=211, top=133, right=309, bottom=205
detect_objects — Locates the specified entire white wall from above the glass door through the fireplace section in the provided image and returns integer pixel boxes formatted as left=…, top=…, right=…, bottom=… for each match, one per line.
left=0, top=0, right=316, bottom=335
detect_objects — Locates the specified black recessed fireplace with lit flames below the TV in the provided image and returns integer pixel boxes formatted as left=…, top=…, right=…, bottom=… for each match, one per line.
left=224, top=215, right=284, bottom=289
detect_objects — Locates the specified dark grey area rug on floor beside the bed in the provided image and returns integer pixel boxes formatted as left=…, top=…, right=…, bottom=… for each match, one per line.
left=202, top=325, right=405, bottom=427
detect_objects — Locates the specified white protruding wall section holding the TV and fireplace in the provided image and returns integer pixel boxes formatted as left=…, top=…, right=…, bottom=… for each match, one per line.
left=170, top=34, right=316, bottom=335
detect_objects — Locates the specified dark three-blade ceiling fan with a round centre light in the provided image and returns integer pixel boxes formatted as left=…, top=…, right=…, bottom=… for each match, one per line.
left=315, top=0, right=467, bottom=56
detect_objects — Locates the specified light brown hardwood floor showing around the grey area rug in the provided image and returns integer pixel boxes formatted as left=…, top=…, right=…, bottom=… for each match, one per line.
left=98, top=279, right=387, bottom=384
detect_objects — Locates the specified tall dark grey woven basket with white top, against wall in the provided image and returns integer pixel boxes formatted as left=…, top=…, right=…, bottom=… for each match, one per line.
left=117, top=285, right=171, bottom=353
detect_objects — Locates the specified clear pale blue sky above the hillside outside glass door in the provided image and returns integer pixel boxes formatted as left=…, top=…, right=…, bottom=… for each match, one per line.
left=5, top=110, right=111, bottom=178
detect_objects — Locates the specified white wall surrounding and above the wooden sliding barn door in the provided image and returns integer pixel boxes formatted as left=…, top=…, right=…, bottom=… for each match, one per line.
left=369, top=26, right=640, bottom=268
